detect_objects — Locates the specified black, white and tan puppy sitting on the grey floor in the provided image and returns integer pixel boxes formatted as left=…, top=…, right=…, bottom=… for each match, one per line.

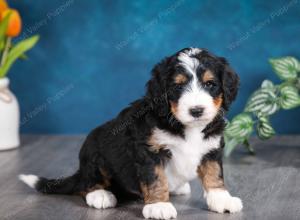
left=19, top=48, right=242, bottom=219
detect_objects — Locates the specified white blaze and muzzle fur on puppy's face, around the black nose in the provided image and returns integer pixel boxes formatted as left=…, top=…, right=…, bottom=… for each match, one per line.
left=176, top=48, right=218, bottom=125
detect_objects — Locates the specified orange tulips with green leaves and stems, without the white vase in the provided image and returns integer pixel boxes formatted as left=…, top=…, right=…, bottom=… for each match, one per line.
left=0, top=0, right=39, bottom=78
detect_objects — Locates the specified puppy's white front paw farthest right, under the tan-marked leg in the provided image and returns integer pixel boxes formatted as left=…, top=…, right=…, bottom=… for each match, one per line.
left=205, top=189, right=243, bottom=213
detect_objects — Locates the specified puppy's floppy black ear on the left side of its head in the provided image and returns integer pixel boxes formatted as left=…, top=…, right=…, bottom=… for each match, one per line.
left=146, top=57, right=171, bottom=116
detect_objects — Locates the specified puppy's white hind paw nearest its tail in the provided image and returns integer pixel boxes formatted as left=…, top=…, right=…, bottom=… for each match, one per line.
left=85, top=189, right=117, bottom=209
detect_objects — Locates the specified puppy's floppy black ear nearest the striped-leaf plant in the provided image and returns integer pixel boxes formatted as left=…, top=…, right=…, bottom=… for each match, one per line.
left=219, top=57, right=240, bottom=111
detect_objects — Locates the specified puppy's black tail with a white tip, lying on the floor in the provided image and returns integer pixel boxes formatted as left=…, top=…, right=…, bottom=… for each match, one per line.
left=19, top=172, right=80, bottom=194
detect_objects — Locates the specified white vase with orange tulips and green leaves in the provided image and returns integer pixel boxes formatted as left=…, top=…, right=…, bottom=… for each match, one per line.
left=0, top=0, right=38, bottom=150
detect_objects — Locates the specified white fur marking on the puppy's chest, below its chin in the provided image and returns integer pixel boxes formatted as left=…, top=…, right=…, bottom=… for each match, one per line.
left=153, top=128, right=221, bottom=191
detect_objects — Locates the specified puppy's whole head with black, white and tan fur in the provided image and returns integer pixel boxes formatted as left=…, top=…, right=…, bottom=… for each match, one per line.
left=148, top=48, right=238, bottom=126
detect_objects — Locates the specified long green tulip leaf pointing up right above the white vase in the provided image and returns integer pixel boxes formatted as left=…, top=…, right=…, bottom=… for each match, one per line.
left=0, top=35, right=39, bottom=77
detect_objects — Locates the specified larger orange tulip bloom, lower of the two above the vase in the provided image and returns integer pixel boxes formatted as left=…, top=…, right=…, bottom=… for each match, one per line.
left=1, top=9, right=22, bottom=37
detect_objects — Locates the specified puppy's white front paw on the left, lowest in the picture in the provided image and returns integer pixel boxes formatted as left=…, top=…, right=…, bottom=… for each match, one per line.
left=143, top=202, right=177, bottom=219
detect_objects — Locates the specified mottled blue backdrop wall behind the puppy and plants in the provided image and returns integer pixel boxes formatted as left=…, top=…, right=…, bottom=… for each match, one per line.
left=9, top=0, right=300, bottom=134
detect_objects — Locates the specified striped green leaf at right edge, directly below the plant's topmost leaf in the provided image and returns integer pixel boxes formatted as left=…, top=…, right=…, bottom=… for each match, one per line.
left=279, top=85, right=300, bottom=109
